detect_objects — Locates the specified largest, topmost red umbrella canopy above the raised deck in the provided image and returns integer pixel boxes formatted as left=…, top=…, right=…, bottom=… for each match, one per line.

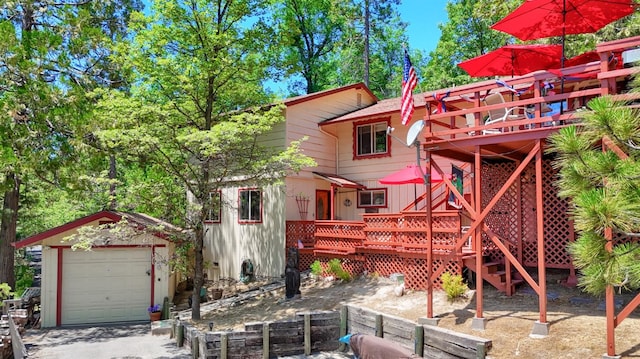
left=491, top=0, right=634, bottom=41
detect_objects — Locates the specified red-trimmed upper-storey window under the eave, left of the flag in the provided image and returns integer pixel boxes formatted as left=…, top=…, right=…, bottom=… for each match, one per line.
left=353, top=119, right=391, bottom=158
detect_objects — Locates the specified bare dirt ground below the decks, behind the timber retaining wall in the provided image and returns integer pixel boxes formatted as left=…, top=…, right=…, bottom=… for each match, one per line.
left=186, top=271, right=640, bottom=359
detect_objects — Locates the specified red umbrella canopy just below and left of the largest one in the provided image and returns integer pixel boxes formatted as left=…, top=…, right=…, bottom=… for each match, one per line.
left=458, top=44, right=562, bottom=77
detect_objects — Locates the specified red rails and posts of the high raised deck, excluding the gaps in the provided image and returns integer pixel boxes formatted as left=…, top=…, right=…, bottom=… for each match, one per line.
left=425, top=36, right=640, bottom=141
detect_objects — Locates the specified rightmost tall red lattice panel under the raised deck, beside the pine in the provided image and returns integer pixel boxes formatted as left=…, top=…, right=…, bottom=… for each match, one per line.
left=522, top=159, right=573, bottom=268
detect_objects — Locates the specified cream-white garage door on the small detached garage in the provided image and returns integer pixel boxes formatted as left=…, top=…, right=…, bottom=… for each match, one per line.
left=61, top=248, right=151, bottom=325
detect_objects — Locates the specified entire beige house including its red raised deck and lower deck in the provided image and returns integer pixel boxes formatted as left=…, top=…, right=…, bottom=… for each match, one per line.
left=202, top=33, right=640, bottom=358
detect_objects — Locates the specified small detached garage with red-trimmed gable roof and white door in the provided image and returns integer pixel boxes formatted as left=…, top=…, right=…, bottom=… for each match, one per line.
left=14, top=211, right=179, bottom=327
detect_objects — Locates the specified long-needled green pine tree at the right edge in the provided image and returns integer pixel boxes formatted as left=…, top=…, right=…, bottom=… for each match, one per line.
left=549, top=75, right=640, bottom=295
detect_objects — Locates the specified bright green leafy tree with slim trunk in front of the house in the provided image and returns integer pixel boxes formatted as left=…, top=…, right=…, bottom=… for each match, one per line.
left=92, top=0, right=312, bottom=319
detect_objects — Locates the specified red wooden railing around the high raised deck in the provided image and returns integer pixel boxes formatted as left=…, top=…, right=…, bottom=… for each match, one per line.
left=425, top=36, right=640, bottom=141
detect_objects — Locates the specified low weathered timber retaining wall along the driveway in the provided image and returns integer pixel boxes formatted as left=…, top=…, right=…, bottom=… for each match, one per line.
left=174, top=305, right=492, bottom=359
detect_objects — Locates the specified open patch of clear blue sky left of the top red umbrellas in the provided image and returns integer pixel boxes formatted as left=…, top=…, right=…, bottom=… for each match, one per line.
left=399, top=0, right=447, bottom=55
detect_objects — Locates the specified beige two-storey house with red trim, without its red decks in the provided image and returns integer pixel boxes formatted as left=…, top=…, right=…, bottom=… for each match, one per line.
left=204, top=83, right=460, bottom=280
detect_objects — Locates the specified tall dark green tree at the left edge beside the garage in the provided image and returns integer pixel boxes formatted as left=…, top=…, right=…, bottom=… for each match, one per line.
left=0, top=0, right=141, bottom=286
